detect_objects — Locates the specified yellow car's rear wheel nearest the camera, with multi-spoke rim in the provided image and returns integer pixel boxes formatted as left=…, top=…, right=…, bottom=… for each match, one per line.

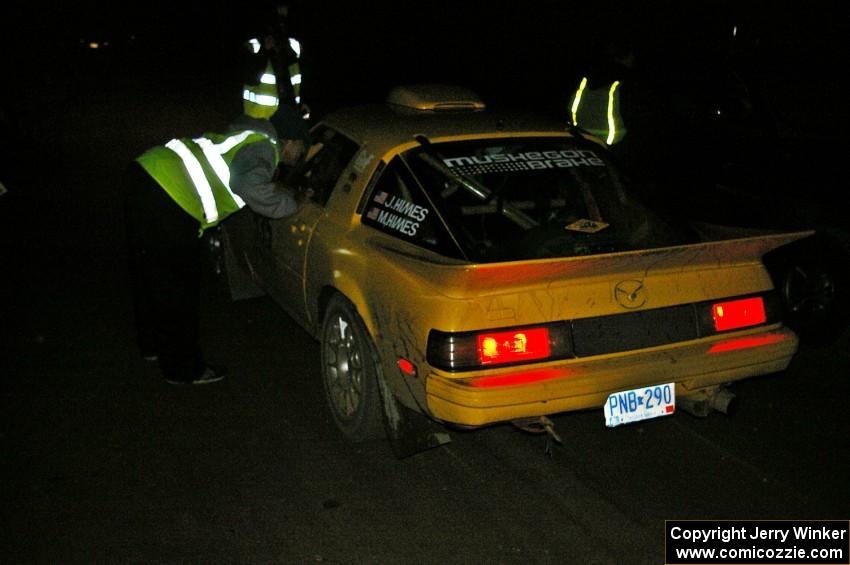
left=322, top=295, right=384, bottom=442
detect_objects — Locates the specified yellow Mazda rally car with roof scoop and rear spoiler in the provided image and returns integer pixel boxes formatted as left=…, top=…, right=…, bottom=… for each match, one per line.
left=220, top=85, right=809, bottom=446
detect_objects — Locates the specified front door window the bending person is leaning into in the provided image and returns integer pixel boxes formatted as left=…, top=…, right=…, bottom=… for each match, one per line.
left=286, top=127, right=358, bottom=206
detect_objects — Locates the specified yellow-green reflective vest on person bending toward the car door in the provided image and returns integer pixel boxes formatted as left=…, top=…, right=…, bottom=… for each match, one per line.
left=136, top=130, right=280, bottom=233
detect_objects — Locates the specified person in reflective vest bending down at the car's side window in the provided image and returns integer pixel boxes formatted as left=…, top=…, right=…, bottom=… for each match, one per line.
left=125, top=106, right=309, bottom=384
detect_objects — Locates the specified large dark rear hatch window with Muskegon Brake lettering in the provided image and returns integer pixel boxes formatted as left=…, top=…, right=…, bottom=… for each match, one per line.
left=364, top=137, right=692, bottom=263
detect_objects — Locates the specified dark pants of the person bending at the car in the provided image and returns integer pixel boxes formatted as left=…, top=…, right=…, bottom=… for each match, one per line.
left=125, top=163, right=205, bottom=380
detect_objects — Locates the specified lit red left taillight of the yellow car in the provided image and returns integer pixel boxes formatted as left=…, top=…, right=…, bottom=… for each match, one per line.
left=428, top=323, right=572, bottom=371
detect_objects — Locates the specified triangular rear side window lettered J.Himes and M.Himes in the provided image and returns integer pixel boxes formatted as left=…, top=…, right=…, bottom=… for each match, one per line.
left=361, top=157, right=461, bottom=258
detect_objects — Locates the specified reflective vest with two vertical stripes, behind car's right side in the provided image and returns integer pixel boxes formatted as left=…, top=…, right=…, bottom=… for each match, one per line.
left=569, top=77, right=626, bottom=145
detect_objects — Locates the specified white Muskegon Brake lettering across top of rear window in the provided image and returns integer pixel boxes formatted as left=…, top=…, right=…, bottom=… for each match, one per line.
left=443, top=149, right=606, bottom=175
